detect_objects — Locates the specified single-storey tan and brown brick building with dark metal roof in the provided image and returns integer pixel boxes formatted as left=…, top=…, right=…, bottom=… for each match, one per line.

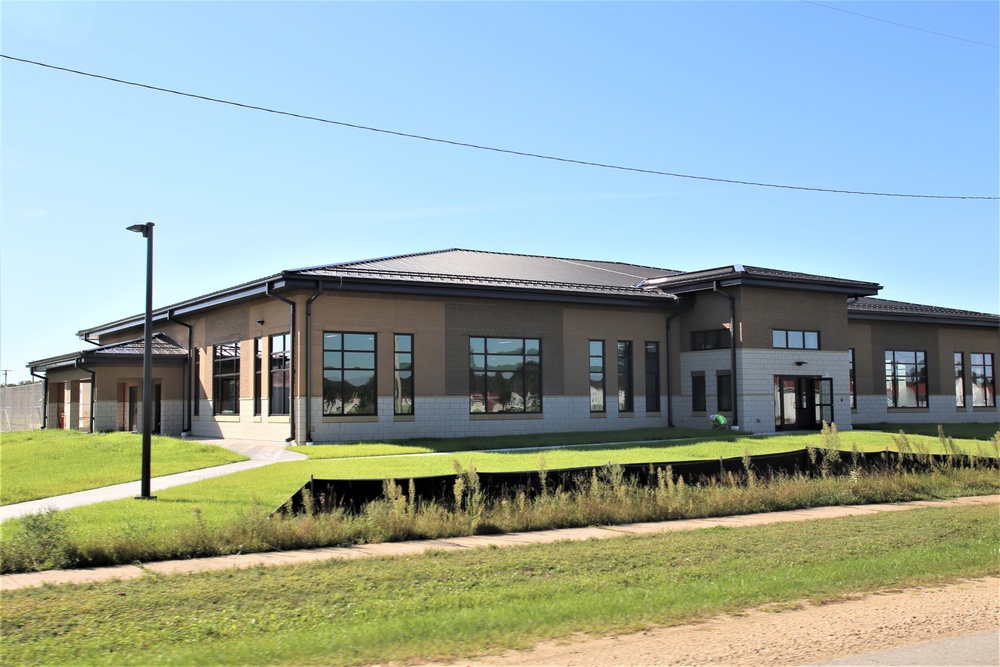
left=29, top=249, right=1000, bottom=443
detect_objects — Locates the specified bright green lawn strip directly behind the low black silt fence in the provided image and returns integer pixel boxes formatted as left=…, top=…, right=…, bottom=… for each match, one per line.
left=27, top=431, right=993, bottom=537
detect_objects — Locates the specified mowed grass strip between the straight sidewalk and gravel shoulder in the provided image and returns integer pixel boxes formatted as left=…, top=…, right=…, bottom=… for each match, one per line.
left=0, top=506, right=1000, bottom=666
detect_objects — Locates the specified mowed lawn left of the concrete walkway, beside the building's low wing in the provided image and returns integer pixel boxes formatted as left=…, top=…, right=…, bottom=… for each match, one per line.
left=0, top=429, right=246, bottom=505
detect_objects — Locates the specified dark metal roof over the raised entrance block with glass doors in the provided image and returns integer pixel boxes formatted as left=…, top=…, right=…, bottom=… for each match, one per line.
left=643, top=264, right=882, bottom=296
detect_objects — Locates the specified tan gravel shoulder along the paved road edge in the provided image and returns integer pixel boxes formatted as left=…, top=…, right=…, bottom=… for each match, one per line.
left=428, top=577, right=1000, bottom=667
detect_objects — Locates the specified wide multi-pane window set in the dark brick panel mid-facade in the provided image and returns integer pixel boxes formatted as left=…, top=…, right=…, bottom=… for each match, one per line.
left=469, top=336, right=542, bottom=413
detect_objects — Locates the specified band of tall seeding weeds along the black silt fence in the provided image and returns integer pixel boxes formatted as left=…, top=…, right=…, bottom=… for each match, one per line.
left=0, top=454, right=1000, bottom=572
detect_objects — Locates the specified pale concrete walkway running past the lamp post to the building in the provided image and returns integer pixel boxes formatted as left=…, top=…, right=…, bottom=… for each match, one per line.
left=0, top=439, right=306, bottom=521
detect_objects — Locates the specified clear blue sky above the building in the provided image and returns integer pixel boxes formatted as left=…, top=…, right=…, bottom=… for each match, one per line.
left=0, top=0, right=1000, bottom=381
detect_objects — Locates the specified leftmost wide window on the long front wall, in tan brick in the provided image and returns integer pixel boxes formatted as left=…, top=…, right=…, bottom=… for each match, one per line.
left=323, top=331, right=376, bottom=417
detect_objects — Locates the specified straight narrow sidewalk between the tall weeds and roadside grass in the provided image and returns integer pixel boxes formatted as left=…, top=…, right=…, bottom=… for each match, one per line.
left=0, top=494, right=1000, bottom=591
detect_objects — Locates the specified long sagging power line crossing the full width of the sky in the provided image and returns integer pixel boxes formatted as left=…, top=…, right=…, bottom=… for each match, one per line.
left=0, top=53, right=1000, bottom=200
